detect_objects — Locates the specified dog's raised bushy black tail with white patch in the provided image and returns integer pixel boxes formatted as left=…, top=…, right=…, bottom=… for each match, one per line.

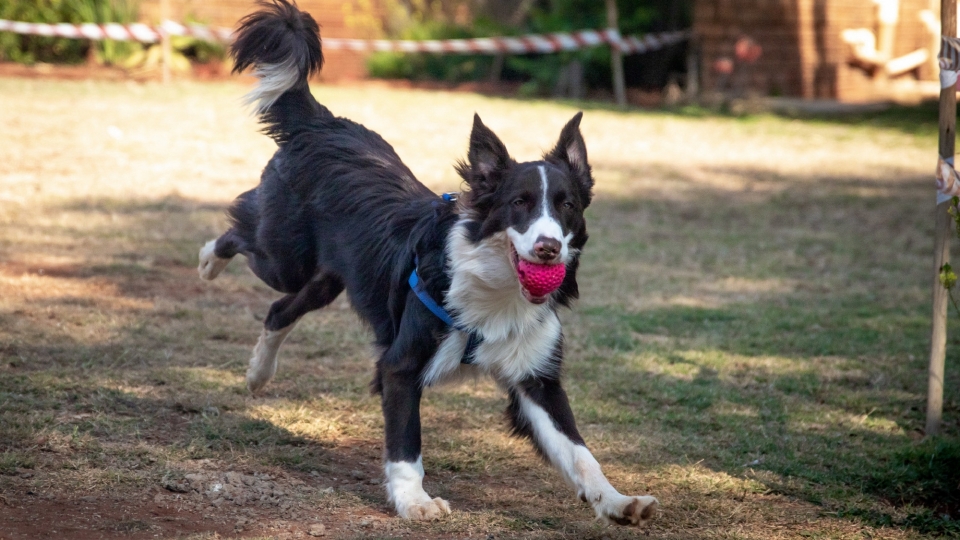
left=230, top=0, right=330, bottom=143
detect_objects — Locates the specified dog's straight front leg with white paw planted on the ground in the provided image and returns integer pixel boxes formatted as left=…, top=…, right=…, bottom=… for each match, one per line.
left=380, top=368, right=450, bottom=520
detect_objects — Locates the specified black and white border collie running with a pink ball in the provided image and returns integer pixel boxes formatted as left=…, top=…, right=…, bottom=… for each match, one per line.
left=199, top=0, right=657, bottom=525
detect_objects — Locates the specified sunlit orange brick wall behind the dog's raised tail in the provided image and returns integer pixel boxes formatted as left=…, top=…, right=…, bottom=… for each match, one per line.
left=140, top=0, right=379, bottom=80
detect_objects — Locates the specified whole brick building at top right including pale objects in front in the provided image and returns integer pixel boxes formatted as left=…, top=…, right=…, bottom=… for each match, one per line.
left=693, top=0, right=940, bottom=101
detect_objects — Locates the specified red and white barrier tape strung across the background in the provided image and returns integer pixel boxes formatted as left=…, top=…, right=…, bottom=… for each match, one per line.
left=0, top=19, right=690, bottom=54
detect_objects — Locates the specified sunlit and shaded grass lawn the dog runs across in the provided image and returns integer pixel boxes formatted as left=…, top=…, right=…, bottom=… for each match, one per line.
left=0, top=79, right=960, bottom=540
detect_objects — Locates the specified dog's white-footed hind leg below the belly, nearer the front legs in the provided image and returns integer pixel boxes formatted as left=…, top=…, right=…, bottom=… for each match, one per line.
left=247, top=272, right=343, bottom=393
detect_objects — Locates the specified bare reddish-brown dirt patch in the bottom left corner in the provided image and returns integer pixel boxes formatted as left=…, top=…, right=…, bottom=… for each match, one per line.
left=0, top=460, right=392, bottom=540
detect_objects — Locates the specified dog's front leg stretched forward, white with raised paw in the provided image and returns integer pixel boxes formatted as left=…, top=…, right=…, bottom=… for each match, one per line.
left=508, top=377, right=657, bottom=525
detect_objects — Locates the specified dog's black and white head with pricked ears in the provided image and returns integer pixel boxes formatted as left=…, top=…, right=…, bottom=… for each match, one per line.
left=457, top=113, right=593, bottom=304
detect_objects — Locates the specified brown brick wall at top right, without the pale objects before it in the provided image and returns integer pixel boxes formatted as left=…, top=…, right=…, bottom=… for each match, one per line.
left=694, top=0, right=937, bottom=101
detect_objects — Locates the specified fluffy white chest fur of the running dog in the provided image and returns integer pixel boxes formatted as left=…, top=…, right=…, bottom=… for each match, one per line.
left=423, top=222, right=561, bottom=386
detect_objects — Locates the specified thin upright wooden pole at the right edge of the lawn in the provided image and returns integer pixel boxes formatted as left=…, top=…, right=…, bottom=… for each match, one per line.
left=926, top=0, right=957, bottom=437
